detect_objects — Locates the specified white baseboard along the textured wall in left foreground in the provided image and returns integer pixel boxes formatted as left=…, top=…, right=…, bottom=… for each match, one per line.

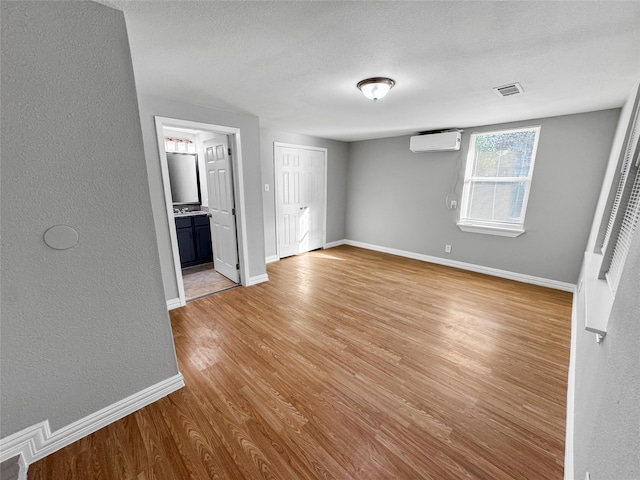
left=0, top=373, right=184, bottom=471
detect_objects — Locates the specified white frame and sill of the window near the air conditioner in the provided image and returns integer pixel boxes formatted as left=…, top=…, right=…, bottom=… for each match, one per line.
left=458, top=125, right=540, bottom=237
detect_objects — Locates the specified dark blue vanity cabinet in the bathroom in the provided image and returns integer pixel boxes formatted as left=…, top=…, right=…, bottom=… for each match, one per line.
left=176, top=215, right=213, bottom=268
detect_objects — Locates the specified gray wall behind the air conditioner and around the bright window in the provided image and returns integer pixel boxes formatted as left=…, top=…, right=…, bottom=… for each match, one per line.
left=346, top=109, right=619, bottom=283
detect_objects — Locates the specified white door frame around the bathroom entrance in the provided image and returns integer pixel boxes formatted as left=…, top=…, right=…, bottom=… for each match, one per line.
left=154, top=115, right=249, bottom=306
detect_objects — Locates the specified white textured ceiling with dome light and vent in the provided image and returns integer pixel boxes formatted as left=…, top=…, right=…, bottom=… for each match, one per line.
left=101, top=0, right=640, bottom=141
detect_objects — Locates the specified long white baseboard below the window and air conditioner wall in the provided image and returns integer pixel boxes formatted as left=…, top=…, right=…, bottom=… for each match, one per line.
left=344, top=240, right=576, bottom=292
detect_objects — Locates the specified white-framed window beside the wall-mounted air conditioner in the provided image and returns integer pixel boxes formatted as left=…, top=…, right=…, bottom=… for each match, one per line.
left=458, top=126, right=540, bottom=237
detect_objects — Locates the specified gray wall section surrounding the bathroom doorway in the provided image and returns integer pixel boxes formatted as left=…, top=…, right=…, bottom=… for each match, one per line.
left=138, top=93, right=266, bottom=300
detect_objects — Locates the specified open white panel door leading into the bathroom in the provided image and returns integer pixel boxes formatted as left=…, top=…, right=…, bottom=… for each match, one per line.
left=204, top=135, right=240, bottom=283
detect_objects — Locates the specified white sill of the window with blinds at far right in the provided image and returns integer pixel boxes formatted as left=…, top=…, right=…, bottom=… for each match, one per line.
left=577, top=252, right=613, bottom=340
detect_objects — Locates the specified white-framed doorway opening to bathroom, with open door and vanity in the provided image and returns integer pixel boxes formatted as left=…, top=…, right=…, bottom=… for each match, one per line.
left=155, top=117, right=247, bottom=306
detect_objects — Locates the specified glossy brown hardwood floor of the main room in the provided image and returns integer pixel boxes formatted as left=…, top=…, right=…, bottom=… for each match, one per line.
left=29, top=246, right=571, bottom=480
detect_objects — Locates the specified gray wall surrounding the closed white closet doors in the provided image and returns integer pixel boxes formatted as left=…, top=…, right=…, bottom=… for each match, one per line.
left=260, top=129, right=349, bottom=257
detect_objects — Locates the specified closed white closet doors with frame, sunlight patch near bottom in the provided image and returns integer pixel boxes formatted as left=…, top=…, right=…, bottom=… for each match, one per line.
left=275, top=144, right=326, bottom=258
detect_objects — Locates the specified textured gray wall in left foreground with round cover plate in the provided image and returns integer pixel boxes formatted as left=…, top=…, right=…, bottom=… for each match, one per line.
left=0, top=1, right=178, bottom=437
